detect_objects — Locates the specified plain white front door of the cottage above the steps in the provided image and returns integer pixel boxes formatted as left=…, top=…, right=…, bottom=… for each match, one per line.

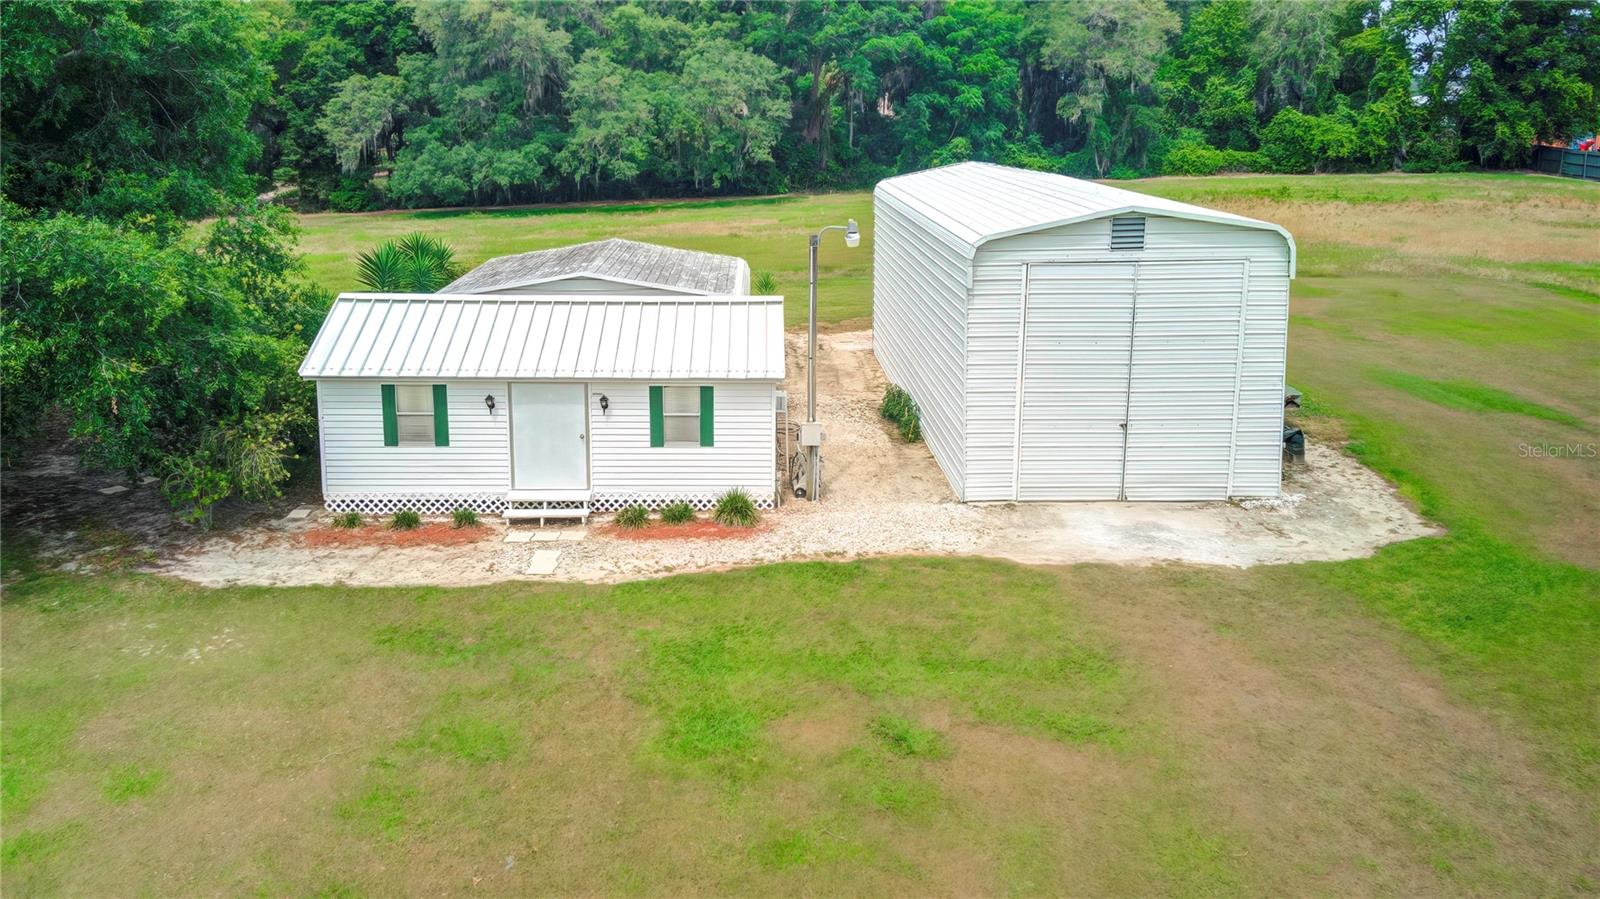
left=510, top=384, right=589, bottom=489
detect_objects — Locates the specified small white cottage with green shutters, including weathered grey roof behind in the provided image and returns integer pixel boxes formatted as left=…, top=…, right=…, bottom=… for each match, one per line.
left=301, top=242, right=784, bottom=520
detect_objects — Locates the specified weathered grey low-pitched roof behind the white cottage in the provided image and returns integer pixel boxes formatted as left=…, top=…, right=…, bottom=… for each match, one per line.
left=443, top=237, right=750, bottom=296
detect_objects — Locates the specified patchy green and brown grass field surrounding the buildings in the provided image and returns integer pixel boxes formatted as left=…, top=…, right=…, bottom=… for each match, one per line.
left=12, top=176, right=1600, bottom=896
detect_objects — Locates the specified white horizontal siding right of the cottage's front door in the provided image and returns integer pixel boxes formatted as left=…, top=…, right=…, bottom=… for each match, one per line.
left=589, top=381, right=778, bottom=497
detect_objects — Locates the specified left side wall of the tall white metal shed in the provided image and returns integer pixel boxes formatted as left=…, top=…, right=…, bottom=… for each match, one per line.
left=872, top=194, right=984, bottom=497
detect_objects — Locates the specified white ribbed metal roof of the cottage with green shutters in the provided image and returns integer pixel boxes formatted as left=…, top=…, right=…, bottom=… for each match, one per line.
left=299, top=293, right=784, bottom=381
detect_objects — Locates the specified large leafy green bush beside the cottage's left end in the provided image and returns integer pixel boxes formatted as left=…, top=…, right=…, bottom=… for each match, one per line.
left=0, top=197, right=328, bottom=526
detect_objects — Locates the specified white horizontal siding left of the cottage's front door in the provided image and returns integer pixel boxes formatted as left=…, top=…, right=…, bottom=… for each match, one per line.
left=317, top=379, right=510, bottom=493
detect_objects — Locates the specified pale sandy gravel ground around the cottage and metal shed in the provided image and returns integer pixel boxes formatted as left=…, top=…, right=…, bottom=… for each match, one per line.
left=8, top=331, right=1435, bottom=585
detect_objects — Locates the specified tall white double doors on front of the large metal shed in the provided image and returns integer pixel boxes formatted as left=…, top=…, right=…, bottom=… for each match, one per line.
left=1016, top=261, right=1245, bottom=501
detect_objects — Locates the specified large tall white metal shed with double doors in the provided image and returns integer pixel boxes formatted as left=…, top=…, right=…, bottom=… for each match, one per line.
left=872, top=163, right=1294, bottom=501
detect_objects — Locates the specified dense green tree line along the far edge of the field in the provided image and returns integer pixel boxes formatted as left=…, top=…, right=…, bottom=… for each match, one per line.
left=251, top=0, right=1600, bottom=210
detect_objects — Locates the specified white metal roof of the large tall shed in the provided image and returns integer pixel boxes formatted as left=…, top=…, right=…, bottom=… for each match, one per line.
left=874, top=162, right=1294, bottom=277
